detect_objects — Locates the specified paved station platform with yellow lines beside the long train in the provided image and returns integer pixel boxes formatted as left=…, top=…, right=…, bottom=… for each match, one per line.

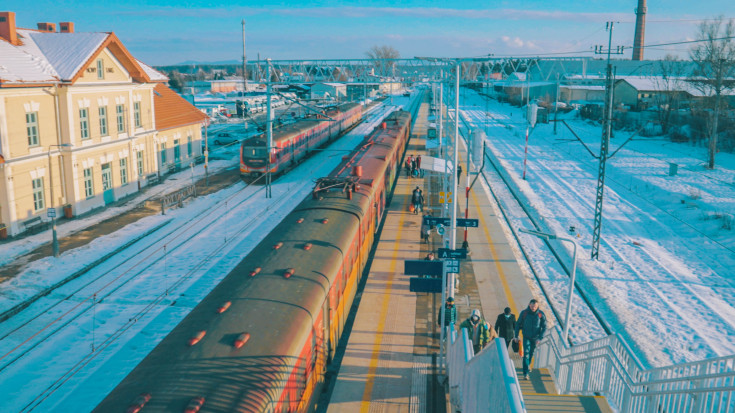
left=319, top=98, right=611, bottom=413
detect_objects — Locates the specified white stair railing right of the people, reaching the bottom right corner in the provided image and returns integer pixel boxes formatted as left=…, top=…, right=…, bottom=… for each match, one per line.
left=534, top=327, right=735, bottom=413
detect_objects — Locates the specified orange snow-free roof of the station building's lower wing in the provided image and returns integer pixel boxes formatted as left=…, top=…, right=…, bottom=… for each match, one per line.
left=153, top=83, right=208, bottom=130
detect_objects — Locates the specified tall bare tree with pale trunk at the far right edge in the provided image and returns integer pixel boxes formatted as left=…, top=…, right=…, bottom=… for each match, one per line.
left=689, top=16, right=735, bottom=169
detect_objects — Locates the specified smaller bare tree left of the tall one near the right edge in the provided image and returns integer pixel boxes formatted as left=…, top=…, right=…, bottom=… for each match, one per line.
left=651, top=55, right=685, bottom=135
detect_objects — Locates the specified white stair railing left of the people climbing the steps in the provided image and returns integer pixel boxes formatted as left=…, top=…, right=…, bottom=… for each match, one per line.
left=447, top=328, right=526, bottom=413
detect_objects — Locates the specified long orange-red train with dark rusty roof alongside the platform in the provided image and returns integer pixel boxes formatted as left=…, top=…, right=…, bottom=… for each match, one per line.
left=95, top=110, right=411, bottom=412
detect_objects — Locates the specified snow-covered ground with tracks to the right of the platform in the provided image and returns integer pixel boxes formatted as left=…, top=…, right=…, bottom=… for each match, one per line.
left=462, top=91, right=735, bottom=367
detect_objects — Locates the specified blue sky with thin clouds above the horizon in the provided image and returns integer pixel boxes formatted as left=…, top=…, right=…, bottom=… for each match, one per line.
left=4, top=0, right=735, bottom=65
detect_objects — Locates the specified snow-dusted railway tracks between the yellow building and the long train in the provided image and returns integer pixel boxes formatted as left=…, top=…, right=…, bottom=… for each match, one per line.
left=0, top=100, right=406, bottom=411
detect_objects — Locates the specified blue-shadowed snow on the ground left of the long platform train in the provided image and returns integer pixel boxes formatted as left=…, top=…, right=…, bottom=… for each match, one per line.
left=0, top=98, right=409, bottom=411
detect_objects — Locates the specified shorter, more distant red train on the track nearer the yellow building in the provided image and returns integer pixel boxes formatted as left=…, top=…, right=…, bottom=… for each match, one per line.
left=240, top=103, right=362, bottom=176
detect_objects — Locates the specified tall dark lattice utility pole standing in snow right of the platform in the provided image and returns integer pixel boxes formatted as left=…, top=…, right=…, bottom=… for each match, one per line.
left=591, top=22, right=623, bottom=260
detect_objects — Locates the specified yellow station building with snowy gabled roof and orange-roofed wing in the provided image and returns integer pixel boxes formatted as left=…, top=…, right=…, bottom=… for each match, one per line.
left=0, top=12, right=207, bottom=236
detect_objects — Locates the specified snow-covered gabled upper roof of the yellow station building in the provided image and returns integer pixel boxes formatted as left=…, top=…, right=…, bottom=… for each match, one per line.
left=0, top=28, right=157, bottom=84
